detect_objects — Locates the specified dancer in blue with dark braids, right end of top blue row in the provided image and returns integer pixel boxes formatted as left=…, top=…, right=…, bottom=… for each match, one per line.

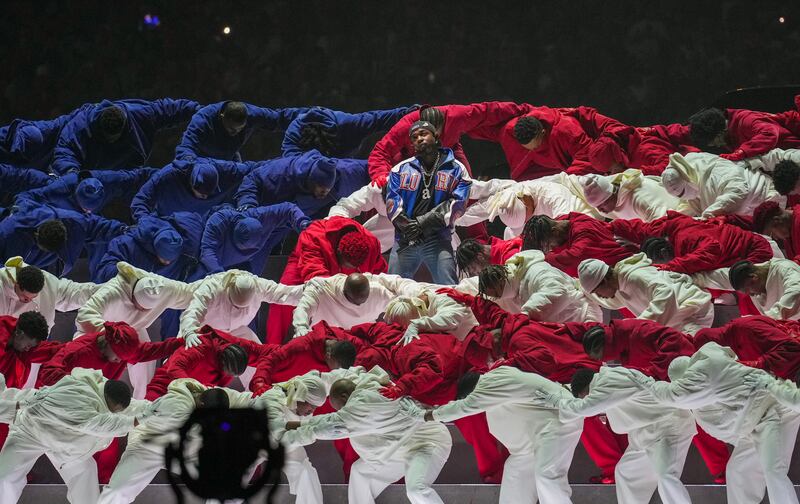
left=281, top=106, right=416, bottom=158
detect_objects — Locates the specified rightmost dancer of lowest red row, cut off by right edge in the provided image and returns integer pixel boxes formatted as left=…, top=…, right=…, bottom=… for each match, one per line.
left=694, top=315, right=800, bottom=380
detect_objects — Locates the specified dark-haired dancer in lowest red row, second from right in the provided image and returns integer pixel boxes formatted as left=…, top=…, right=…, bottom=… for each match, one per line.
left=566, top=319, right=730, bottom=481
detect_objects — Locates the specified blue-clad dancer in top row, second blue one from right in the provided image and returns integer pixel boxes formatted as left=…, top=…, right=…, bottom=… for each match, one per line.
left=175, top=101, right=307, bottom=161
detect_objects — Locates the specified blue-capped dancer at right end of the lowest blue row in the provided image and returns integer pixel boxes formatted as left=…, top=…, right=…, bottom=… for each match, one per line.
left=200, top=203, right=311, bottom=275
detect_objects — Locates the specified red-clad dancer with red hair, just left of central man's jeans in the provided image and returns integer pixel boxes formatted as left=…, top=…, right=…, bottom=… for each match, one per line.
left=267, top=217, right=388, bottom=344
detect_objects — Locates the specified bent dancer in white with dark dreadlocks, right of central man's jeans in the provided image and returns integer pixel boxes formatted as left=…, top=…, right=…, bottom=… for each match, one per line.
left=476, top=250, right=603, bottom=322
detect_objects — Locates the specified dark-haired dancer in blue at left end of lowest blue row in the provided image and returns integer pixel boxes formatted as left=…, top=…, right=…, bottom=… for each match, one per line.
left=0, top=200, right=127, bottom=276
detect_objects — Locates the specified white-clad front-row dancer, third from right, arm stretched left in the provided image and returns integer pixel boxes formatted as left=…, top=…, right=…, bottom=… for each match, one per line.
left=412, top=366, right=583, bottom=504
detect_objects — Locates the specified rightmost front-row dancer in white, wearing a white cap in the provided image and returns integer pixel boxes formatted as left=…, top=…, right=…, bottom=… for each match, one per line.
left=642, top=342, right=800, bottom=504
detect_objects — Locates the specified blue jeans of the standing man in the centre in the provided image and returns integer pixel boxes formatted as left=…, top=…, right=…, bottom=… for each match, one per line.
left=389, top=236, right=458, bottom=285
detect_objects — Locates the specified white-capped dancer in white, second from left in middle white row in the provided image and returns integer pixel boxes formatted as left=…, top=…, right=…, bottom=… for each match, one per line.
left=75, top=262, right=200, bottom=399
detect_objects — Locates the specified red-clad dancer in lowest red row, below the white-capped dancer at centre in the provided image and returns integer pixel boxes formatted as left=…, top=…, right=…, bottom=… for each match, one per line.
left=348, top=322, right=506, bottom=483
